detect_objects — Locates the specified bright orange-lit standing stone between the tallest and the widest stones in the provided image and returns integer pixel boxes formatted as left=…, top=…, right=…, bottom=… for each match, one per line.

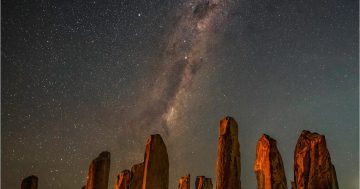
left=254, top=134, right=287, bottom=189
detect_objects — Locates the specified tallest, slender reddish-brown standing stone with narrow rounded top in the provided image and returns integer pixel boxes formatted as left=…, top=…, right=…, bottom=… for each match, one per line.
left=216, top=117, right=241, bottom=189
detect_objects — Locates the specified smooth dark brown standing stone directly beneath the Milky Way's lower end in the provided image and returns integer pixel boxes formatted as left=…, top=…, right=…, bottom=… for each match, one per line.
left=142, top=134, right=169, bottom=189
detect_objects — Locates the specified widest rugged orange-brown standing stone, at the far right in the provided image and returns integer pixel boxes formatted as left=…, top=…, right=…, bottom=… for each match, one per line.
left=294, top=131, right=339, bottom=189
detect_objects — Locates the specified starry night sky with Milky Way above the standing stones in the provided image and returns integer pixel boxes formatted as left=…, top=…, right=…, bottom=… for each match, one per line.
left=1, top=0, right=359, bottom=189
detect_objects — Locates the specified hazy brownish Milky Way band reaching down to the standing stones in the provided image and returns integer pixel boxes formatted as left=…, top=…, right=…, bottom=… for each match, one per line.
left=116, top=0, right=237, bottom=183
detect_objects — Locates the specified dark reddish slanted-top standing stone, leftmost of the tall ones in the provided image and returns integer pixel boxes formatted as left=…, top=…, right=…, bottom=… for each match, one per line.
left=86, top=151, right=110, bottom=189
